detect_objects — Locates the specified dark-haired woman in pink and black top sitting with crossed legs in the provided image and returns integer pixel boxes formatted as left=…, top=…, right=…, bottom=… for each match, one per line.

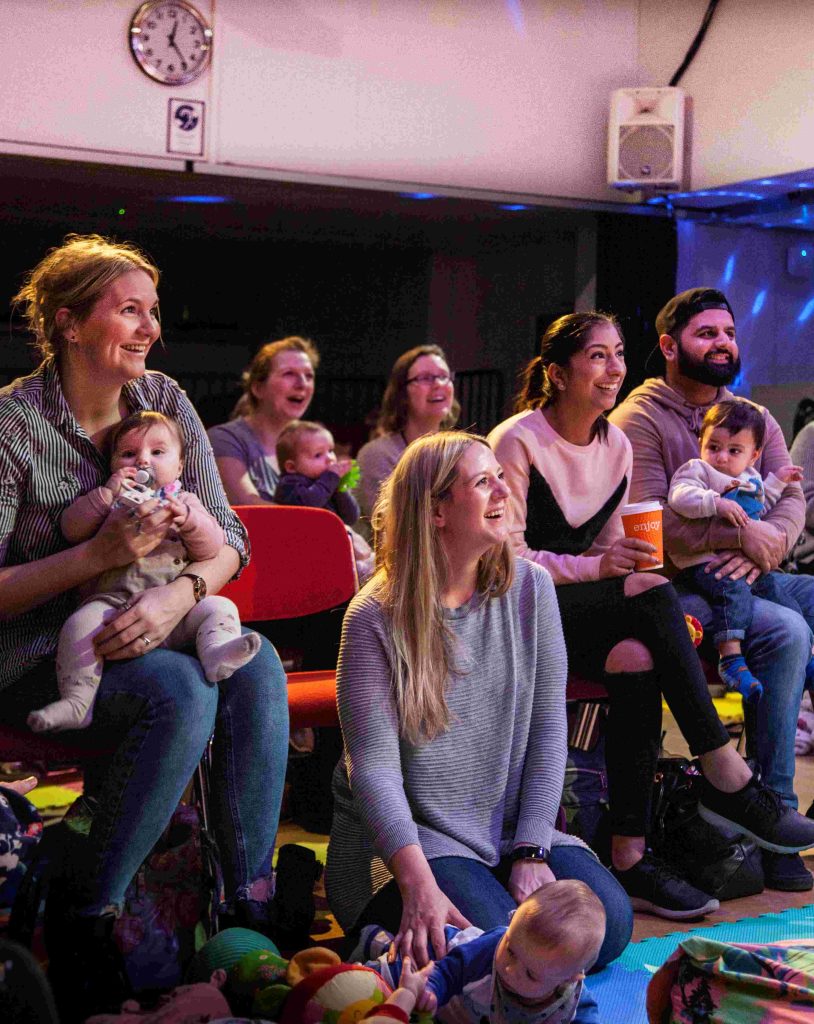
left=489, top=312, right=810, bottom=919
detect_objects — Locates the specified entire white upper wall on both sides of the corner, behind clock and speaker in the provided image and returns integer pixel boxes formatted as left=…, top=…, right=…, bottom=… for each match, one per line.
left=0, top=0, right=814, bottom=200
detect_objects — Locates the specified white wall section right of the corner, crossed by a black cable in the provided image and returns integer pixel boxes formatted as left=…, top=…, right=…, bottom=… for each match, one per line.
left=638, top=0, right=814, bottom=188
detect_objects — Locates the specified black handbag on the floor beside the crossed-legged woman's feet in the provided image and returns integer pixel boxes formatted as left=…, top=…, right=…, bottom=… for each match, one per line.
left=648, top=758, right=764, bottom=900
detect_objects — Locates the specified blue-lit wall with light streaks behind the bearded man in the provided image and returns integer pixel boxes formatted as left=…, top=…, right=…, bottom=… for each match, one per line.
left=676, top=221, right=814, bottom=436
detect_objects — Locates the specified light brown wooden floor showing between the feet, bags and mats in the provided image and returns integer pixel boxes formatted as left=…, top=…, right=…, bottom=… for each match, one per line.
left=277, top=715, right=814, bottom=942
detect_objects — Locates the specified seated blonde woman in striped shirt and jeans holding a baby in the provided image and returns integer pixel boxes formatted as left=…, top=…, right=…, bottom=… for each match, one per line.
left=0, top=236, right=288, bottom=1020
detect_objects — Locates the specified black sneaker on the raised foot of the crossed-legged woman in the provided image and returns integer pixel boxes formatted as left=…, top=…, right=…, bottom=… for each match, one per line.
left=698, top=777, right=814, bottom=853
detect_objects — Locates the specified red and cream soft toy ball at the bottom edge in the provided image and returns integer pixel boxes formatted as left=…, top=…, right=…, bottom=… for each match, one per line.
left=281, top=964, right=392, bottom=1024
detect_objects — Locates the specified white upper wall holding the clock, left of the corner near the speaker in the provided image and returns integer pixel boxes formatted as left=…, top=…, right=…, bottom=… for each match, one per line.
left=0, top=0, right=637, bottom=199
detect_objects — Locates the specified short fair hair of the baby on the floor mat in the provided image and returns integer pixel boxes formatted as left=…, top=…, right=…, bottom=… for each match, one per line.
left=518, top=879, right=606, bottom=972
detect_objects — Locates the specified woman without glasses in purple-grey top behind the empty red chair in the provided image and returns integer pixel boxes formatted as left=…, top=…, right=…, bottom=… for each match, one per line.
left=209, top=336, right=319, bottom=505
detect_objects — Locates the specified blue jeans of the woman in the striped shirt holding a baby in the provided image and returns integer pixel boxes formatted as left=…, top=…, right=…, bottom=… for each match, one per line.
left=0, top=640, right=289, bottom=914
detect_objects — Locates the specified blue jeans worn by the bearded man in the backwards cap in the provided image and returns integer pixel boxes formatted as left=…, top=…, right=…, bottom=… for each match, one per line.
left=676, top=572, right=814, bottom=808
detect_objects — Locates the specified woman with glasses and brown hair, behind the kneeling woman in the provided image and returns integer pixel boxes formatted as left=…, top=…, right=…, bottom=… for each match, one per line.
left=356, top=345, right=461, bottom=539
